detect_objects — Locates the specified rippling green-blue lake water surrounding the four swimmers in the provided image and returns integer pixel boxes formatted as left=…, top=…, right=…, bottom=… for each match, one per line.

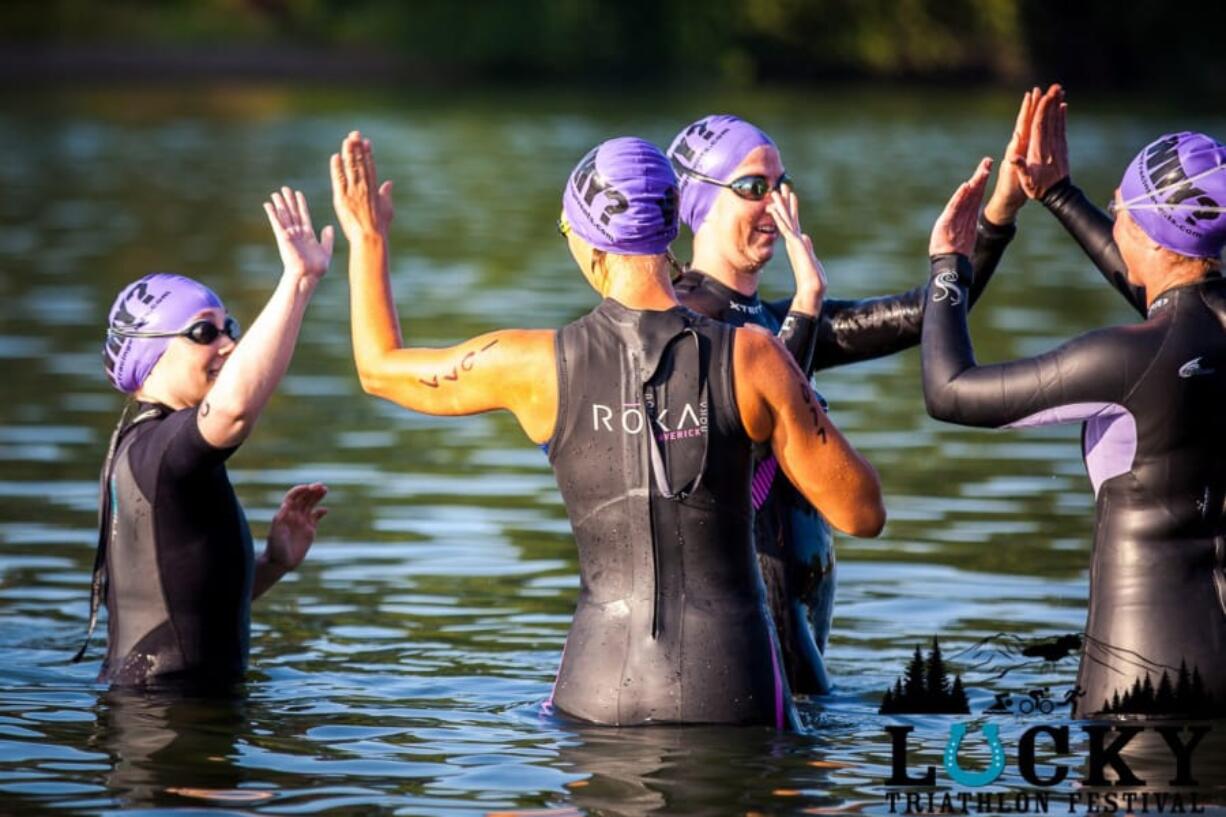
left=0, top=87, right=1226, bottom=816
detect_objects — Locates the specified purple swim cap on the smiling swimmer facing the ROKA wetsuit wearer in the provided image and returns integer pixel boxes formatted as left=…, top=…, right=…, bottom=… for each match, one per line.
left=668, top=114, right=775, bottom=233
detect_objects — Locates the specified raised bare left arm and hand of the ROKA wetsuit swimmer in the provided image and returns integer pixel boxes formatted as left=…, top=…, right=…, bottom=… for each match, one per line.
left=332, top=132, right=558, bottom=443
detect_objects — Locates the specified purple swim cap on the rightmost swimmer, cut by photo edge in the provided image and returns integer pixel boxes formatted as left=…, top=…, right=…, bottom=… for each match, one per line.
left=1119, top=131, right=1226, bottom=258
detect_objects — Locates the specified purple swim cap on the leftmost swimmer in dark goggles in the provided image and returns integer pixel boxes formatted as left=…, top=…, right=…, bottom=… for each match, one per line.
left=102, top=272, right=224, bottom=394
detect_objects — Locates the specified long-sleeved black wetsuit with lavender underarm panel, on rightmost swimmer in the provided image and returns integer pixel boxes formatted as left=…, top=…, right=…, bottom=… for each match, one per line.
left=923, top=255, right=1226, bottom=714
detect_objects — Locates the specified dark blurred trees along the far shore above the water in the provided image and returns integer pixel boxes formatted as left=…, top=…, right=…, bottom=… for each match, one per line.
left=0, top=0, right=1226, bottom=107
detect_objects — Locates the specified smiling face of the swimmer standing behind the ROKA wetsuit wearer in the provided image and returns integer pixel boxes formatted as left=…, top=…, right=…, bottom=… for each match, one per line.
left=694, top=145, right=783, bottom=274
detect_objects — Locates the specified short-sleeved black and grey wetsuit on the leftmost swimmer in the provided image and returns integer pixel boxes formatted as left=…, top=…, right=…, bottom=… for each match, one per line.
left=89, top=404, right=255, bottom=687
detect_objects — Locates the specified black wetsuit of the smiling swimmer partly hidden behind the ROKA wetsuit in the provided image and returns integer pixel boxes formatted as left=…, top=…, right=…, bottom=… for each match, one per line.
left=676, top=213, right=1016, bottom=694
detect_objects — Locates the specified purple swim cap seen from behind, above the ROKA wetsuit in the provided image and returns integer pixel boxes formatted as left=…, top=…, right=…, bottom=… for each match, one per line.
left=562, top=136, right=677, bottom=255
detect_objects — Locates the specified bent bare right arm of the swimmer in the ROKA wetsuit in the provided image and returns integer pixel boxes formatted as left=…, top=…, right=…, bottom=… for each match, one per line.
left=733, top=326, right=885, bottom=536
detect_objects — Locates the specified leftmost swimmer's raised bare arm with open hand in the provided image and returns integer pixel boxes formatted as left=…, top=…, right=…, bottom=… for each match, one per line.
left=196, top=188, right=332, bottom=448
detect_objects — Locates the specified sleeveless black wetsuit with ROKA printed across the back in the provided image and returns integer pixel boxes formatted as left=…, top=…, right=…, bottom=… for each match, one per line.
left=548, top=301, right=794, bottom=727
